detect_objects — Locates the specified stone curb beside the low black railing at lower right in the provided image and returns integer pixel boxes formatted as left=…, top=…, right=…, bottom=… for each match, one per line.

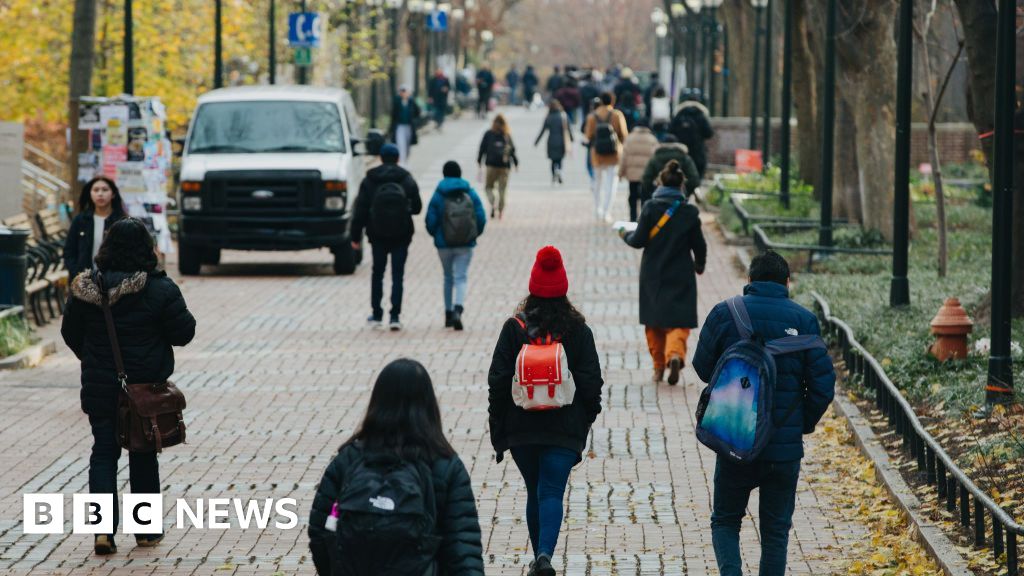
left=833, top=394, right=974, bottom=576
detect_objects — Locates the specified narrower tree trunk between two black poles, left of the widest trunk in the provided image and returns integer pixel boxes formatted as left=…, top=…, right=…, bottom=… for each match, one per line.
left=793, top=0, right=821, bottom=195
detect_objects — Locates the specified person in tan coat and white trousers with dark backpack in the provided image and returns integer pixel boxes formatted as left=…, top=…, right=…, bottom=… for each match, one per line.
left=584, top=92, right=629, bottom=222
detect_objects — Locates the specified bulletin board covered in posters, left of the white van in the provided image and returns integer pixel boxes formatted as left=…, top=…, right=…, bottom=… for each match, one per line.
left=78, top=95, right=173, bottom=254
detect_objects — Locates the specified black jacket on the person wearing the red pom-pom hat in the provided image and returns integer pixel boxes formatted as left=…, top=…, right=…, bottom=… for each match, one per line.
left=487, top=318, right=604, bottom=456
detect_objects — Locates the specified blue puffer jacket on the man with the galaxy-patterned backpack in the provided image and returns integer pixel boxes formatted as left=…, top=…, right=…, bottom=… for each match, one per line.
left=693, top=282, right=836, bottom=462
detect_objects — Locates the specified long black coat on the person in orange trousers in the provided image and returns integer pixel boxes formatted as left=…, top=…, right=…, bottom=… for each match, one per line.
left=625, top=188, right=708, bottom=328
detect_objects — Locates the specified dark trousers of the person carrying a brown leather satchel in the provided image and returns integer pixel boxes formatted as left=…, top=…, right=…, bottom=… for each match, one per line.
left=89, top=416, right=160, bottom=534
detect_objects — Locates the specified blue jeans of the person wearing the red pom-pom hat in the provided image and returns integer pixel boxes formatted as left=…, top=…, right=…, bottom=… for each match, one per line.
left=511, top=445, right=580, bottom=558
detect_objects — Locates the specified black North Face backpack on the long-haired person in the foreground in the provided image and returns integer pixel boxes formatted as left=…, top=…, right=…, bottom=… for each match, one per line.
left=331, top=453, right=441, bottom=576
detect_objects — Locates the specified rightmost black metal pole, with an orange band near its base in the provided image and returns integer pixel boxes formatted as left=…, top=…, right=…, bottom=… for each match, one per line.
left=985, top=0, right=1017, bottom=405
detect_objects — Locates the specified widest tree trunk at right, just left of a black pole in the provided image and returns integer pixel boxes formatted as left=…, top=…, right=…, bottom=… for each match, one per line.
left=837, top=0, right=897, bottom=241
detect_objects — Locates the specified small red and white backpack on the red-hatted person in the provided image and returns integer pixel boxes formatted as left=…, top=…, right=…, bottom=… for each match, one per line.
left=512, top=318, right=575, bottom=411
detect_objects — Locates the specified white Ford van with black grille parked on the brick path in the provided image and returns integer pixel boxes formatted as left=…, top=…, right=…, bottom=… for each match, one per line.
left=178, top=86, right=364, bottom=275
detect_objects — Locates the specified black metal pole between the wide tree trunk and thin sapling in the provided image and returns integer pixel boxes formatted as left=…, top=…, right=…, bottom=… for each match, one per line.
left=889, top=0, right=913, bottom=306
